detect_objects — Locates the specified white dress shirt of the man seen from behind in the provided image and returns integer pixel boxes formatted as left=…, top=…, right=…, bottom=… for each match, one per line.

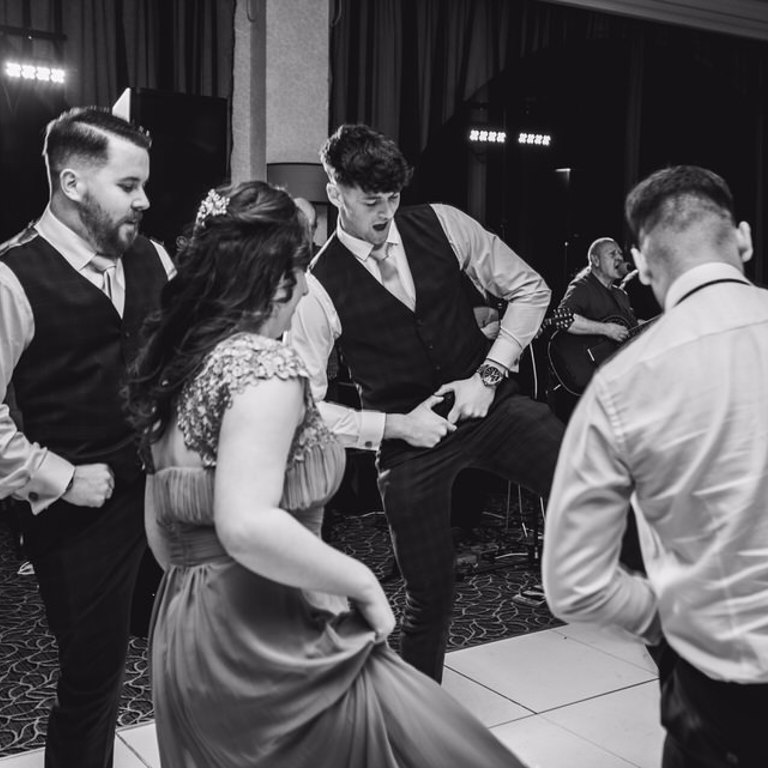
left=543, top=263, right=768, bottom=683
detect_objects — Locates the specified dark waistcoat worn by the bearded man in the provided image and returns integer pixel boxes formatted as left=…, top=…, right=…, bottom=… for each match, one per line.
left=2, top=236, right=166, bottom=474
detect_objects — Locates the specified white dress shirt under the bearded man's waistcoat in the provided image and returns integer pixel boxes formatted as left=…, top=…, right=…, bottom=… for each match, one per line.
left=0, top=207, right=174, bottom=514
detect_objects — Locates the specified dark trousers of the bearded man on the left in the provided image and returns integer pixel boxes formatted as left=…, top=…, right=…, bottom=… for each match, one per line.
left=24, top=475, right=147, bottom=768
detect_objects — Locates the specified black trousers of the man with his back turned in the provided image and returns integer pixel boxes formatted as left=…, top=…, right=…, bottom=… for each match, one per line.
left=660, top=646, right=768, bottom=768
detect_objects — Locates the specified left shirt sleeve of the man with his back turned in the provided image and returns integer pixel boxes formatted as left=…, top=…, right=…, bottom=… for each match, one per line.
left=542, top=377, right=659, bottom=642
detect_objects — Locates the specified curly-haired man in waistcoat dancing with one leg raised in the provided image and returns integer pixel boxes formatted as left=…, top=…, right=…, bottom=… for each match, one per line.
left=290, top=125, right=562, bottom=681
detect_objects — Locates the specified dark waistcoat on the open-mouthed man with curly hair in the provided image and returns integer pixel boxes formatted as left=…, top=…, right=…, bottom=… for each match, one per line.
left=312, top=205, right=489, bottom=413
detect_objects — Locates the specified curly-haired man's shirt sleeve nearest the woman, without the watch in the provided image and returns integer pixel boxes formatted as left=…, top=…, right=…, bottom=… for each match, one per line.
left=286, top=274, right=386, bottom=450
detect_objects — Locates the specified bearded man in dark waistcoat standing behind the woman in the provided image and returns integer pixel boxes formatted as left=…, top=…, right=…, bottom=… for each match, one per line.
left=0, top=107, right=173, bottom=768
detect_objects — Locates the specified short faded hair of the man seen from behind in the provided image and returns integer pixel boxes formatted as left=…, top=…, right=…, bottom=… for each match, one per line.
left=624, top=165, right=735, bottom=242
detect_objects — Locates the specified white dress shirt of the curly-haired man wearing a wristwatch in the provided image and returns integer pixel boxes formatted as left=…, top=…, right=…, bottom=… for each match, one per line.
left=288, top=204, right=550, bottom=450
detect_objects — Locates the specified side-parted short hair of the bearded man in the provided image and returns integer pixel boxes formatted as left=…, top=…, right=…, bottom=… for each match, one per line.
left=43, top=107, right=152, bottom=179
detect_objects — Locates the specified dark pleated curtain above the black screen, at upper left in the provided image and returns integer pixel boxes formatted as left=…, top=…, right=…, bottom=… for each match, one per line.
left=0, top=0, right=235, bottom=106
